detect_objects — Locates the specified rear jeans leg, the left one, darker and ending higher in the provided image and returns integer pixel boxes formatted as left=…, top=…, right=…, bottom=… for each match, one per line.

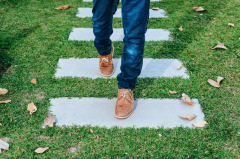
left=92, top=0, right=118, bottom=56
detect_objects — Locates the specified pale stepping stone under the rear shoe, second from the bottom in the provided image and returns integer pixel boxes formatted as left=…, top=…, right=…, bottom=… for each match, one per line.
left=55, top=58, right=189, bottom=79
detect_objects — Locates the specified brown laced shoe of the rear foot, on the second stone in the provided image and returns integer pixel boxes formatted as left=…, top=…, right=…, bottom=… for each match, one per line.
left=99, top=45, right=114, bottom=77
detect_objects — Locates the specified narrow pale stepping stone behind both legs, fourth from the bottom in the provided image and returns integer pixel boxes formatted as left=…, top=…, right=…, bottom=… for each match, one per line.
left=76, top=8, right=167, bottom=18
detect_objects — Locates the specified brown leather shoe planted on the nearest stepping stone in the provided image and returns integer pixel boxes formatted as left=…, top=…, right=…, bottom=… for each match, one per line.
left=115, top=89, right=134, bottom=119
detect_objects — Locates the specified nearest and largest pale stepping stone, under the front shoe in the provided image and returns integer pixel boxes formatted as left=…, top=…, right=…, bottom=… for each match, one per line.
left=50, top=97, right=204, bottom=128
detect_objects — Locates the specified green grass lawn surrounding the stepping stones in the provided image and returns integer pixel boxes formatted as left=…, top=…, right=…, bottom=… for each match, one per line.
left=0, top=0, right=240, bottom=158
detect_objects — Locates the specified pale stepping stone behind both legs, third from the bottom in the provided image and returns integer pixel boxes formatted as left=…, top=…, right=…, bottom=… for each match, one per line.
left=68, top=28, right=170, bottom=41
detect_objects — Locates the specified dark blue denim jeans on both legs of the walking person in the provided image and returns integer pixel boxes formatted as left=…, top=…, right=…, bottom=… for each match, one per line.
left=92, top=0, right=150, bottom=90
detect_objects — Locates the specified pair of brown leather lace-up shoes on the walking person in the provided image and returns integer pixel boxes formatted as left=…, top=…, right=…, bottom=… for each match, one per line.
left=99, top=46, right=134, bottom=119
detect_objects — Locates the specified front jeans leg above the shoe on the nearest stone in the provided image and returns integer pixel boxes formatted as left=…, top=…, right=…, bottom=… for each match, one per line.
left=117, top=0, right=150, bottom=90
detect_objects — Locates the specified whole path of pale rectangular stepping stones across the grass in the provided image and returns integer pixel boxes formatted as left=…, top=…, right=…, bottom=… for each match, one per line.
left=50, top=0, right=204, bottom=128
